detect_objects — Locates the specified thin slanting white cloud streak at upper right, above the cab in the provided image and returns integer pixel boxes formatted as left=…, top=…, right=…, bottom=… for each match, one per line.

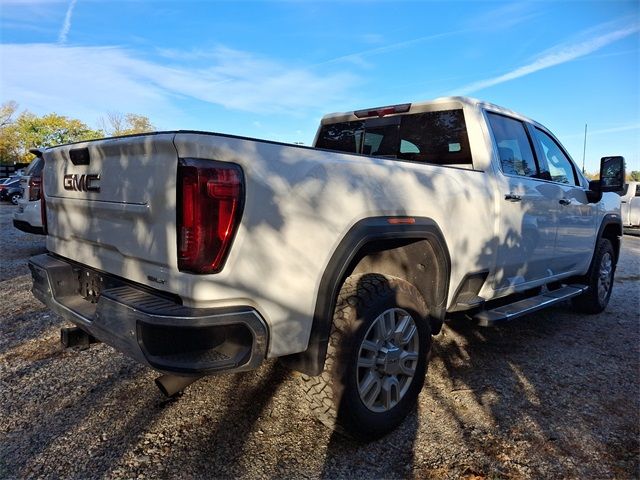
left=454, top=24, right=640, bottom=95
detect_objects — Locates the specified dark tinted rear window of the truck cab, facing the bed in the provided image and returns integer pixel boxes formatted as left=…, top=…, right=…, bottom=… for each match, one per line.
left=316, top=109, right=472, bottom=165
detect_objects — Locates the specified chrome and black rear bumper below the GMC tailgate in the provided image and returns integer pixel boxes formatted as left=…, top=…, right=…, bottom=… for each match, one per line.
left=29, top=254, right=267, bottom=375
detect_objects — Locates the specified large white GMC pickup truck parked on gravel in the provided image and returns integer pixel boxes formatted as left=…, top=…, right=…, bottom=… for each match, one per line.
left=30, top=97, right=624, bottom=438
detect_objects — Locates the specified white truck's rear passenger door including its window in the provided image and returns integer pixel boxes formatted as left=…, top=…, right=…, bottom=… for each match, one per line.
left=487, top=112, right=559, bottom=290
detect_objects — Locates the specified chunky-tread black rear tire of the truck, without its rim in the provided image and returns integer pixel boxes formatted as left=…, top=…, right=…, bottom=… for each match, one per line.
left=299, top=274, right=431, bottom=440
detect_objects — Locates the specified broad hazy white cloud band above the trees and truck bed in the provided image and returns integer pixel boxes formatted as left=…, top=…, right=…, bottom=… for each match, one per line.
left=0, top=44, right=359, bottom=125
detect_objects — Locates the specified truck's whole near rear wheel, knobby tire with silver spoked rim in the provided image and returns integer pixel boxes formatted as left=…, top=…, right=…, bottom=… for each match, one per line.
left=301, top=274, right=431, bottom=439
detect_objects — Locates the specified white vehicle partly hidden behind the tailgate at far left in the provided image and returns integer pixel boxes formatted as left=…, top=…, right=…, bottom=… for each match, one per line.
left=13, top=150, right=45, bottom=235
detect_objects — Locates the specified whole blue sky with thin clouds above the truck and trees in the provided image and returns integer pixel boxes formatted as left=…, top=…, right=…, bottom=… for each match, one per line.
left=0, top=0, right=640, bottom=171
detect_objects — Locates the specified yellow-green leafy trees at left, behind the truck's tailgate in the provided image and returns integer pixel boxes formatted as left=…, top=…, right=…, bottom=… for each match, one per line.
left=0, top=100, right=155, bottom=163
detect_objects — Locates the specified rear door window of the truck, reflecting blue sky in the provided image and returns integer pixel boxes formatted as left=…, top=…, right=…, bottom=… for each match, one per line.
left=487, top=113, right=538, bottom=177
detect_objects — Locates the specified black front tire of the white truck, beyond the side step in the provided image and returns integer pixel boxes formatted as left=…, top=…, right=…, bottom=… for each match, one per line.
left=571, top=238, right=616, bottom=314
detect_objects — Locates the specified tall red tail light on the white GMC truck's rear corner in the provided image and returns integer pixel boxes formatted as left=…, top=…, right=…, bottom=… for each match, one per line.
left=177, top=158, right=244, bottom=273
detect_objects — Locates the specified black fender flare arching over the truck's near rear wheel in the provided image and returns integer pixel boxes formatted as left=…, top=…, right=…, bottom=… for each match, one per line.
left=281, top=216, right=451, bottom=375
